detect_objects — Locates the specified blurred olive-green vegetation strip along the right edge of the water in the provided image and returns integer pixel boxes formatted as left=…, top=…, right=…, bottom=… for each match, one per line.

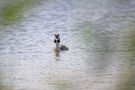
left=123, top=23, right=135, bottom=90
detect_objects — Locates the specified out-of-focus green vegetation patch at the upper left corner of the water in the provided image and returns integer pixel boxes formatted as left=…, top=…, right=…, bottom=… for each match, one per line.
left=0, top=0, right=37, bottom=25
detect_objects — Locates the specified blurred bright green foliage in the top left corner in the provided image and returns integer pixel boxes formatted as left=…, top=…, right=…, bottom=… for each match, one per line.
left=1, top=0, right=36, bottom=25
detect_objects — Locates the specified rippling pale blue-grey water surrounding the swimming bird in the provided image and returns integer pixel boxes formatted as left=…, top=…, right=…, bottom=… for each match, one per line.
left=0, top=0, right=135, bottom=90
